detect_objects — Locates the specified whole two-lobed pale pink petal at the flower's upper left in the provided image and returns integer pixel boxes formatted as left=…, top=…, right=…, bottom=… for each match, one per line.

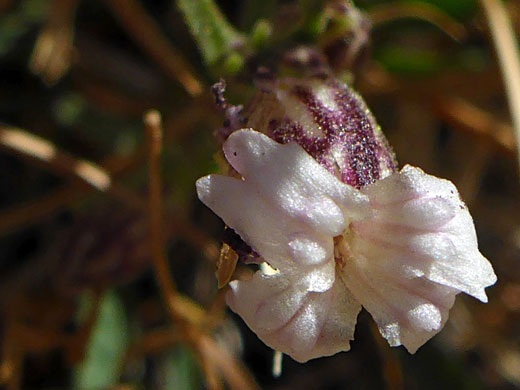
left=197, top=130, right=368, bottom=291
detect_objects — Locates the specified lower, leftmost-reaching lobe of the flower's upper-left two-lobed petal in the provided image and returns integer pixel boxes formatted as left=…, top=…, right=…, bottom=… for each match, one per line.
left=197, top=175, right=334, bottom=291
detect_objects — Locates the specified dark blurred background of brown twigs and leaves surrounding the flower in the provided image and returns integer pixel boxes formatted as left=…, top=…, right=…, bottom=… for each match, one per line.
left=0, top=0, right=520, bottom=390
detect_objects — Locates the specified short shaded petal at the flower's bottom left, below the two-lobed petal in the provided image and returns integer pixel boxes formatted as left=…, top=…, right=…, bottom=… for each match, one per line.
left=226, top=272, right=361, bottom=362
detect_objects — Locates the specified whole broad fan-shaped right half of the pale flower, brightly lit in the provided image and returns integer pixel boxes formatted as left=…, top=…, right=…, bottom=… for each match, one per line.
left=341, top=166, right=496, bottom=352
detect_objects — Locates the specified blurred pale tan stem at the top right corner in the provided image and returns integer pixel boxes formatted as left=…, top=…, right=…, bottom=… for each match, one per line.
left=481, top=0, right=520, bottom=172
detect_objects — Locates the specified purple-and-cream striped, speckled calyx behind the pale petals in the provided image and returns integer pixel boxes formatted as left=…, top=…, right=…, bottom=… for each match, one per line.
left=245, top=77, right=397, bottom=188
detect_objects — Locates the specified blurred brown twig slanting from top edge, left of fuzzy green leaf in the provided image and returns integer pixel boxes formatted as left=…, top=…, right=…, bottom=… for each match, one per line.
left=106, top=0, right=202, bottom=96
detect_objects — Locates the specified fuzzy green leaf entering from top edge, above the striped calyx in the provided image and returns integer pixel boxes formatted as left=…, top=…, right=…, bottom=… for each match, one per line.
left=177, top=0, right=244, bottom=65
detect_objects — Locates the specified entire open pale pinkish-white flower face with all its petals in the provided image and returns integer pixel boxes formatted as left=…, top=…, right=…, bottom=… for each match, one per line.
left=197, top=129, right=496, bottom=362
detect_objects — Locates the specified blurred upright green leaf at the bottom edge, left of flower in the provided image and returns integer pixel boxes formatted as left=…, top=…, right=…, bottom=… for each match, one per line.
left=73, top=291, right=128, bottom=390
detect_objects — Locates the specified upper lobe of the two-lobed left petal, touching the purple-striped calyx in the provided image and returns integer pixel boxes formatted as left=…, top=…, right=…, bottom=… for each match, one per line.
left=223, top=130, right=368, bottom=236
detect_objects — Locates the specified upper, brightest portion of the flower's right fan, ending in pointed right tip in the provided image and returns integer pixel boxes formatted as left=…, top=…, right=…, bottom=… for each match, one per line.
left=358, top=166, right=496, bottom=302
